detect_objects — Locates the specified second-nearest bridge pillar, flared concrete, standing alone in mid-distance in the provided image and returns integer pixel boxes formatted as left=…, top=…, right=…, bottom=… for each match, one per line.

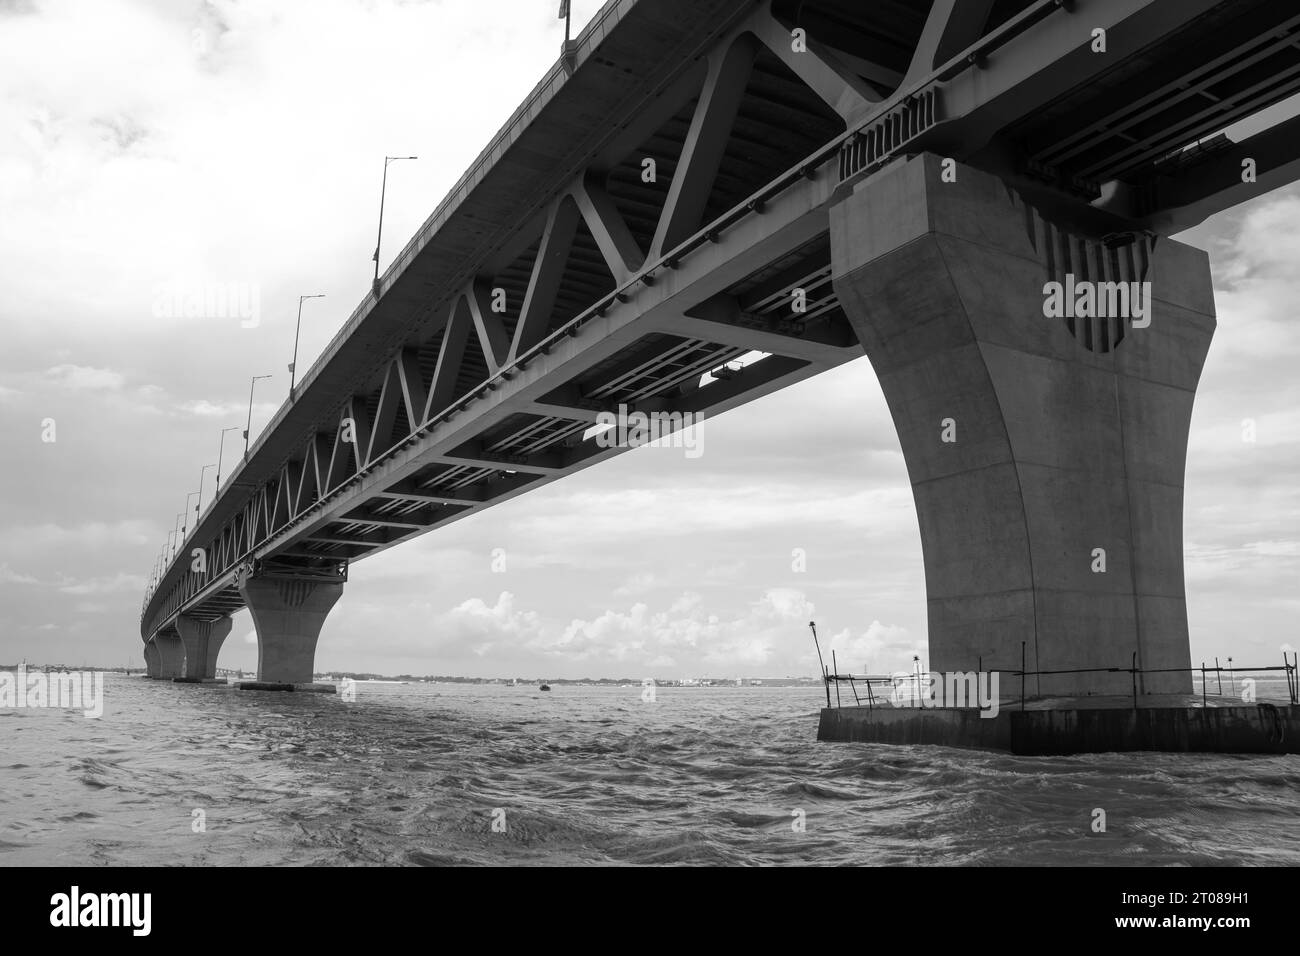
left=239, top=574, right=343, bottom=684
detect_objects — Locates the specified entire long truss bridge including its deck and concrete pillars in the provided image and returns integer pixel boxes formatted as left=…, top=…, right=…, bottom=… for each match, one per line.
left=140, top=0, right=1300, bottom=693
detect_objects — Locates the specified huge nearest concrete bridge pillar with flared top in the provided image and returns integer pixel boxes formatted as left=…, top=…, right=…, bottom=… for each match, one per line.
left=831, top=153, right=1216, bottom=696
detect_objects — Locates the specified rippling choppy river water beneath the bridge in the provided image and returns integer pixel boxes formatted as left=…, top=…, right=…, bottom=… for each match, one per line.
left=0, top=675, right=1300, bottom=865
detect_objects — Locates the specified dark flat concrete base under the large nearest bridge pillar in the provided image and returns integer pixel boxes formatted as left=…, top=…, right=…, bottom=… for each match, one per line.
left=818, top=695, right=1300, bottom=756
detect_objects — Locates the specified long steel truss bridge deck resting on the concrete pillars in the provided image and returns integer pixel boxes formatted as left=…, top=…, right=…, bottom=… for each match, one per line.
left=142, top=0, right=1300, bottom=640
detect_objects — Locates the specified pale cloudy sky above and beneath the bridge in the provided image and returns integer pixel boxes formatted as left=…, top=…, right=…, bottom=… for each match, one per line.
left=0, top=0, right=1300, bottom=678
